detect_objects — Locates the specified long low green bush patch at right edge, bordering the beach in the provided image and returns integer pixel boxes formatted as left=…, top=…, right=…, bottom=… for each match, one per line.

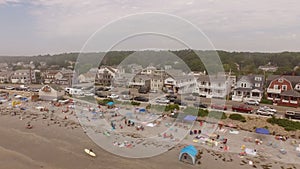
left=267, top=117, right=300, bottom=131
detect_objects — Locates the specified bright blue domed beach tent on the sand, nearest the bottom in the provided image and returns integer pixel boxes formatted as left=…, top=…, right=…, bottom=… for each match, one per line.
left=179, top=145, right=198, bottom=164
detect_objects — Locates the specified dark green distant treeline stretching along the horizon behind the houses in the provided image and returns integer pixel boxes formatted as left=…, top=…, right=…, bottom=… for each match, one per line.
left=0, top=50, right=300, bottom=75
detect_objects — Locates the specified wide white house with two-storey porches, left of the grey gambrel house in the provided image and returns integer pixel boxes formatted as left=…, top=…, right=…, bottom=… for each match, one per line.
left=196, top=74, right=235, bottom=98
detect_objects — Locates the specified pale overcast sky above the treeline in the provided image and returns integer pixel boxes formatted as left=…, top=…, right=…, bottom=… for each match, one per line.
left=0, top=0, right=300, bottom=56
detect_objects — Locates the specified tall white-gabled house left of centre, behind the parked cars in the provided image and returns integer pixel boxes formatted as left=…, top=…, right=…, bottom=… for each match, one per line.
left=95, top=66, right=118, bottom=86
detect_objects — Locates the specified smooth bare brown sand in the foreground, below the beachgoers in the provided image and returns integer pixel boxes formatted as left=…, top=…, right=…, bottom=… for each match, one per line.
left=0, top=115, right=300, bottom=169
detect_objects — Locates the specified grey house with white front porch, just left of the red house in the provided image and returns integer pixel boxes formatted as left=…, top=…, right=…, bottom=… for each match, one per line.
left=232, top=75, right=264, bottom=101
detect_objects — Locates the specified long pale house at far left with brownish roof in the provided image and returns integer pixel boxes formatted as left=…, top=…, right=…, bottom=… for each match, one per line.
left=11, top=69, right=36, bottom=84
